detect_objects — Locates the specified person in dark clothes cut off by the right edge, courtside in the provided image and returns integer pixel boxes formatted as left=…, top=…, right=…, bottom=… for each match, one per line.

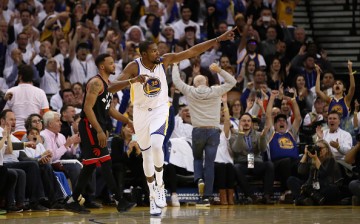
left=345, top=134, right=360, bottom=205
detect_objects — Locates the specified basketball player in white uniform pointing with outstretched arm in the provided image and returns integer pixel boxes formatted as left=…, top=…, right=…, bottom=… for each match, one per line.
left=109, top=29, right=235, bottom=216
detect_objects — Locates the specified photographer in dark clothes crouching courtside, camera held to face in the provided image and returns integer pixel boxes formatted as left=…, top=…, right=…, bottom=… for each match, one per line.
left=287, top=140, right=341, bottom=205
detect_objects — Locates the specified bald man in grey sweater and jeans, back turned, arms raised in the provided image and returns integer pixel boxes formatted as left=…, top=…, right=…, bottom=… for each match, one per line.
left=172, top=63, right=236, bottom=206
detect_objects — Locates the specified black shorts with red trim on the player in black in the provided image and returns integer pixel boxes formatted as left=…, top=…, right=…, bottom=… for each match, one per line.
left=79, top=118, right=111, bottom=165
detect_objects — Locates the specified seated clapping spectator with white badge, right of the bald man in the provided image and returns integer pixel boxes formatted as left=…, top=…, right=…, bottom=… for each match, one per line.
left=231, top=113, right=274, bottom=204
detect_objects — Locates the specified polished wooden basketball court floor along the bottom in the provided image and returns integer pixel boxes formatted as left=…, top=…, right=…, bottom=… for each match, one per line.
left=0, top=205, right=360, bottom=224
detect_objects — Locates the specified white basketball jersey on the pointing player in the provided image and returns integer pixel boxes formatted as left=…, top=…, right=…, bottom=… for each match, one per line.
left=131, top=58, right=169, bottom=108
